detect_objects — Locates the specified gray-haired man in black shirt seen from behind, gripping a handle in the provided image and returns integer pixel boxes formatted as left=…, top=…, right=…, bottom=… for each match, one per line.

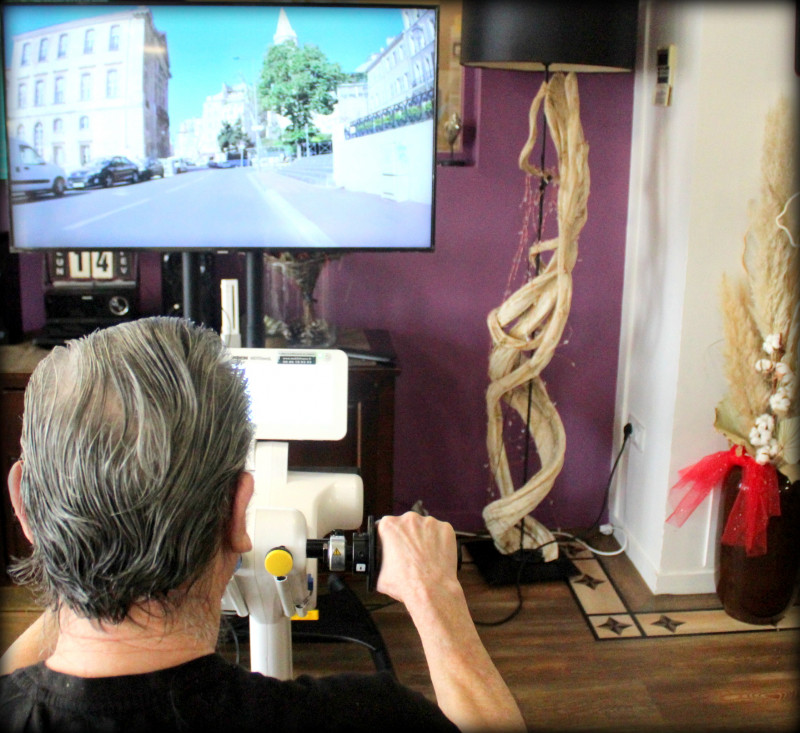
left=0, top=317, right=525, bottom=731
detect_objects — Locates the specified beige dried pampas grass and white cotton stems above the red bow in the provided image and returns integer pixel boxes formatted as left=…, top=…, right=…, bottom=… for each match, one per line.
left=714, top=94, right=800, bottom=481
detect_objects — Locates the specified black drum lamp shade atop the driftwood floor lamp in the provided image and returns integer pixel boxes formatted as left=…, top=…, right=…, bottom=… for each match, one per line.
left=461, top=0, right=638, bottom=72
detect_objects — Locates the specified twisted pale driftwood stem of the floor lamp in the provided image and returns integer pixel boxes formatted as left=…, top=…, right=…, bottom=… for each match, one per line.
left=483, top=73, right=589, bottom=561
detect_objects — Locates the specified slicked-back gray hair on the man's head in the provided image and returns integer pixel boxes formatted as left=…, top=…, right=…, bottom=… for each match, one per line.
left=12, top=317, right=253, bottom=623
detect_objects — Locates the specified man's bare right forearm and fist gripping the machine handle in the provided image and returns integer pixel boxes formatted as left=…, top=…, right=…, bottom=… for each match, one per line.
left=377, top=512, right=526, bottom=731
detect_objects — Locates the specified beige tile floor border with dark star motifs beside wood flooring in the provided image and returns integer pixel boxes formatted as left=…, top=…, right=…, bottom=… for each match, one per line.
left=568, top=550, right=800, bottom=641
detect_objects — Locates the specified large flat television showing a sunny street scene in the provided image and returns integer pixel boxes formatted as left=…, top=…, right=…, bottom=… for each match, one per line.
left=2, top=2, right=438, bottom=252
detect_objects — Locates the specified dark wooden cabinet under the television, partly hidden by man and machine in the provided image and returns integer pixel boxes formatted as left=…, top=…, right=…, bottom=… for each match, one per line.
left=0, top=331, right=400, bottom=584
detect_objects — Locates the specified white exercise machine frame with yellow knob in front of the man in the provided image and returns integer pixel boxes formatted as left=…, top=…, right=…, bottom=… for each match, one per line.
left=222, top=348, right=364, bottom=679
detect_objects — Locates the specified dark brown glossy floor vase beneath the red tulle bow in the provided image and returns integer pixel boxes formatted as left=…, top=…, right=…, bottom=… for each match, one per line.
left=716, top=466, right=800, bottom=625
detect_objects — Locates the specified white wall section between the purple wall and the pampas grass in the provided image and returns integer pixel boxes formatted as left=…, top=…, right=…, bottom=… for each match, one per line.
left=611, top=1, right=798, bottom=593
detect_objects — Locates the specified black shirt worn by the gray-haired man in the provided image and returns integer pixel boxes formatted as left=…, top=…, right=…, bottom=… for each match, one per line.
left=0, top=654, right=457, bottom=733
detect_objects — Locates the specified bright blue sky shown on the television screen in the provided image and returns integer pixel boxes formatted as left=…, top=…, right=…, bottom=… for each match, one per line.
left=4, top=2, right=403, bottom=127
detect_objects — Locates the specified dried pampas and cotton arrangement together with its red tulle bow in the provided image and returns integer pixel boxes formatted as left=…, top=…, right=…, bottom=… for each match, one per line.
left=667, top=99, right=800, bottom=556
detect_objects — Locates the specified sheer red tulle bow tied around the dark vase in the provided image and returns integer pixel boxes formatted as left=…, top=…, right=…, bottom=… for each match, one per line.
left=667, top=446, right=781, bottom=557
